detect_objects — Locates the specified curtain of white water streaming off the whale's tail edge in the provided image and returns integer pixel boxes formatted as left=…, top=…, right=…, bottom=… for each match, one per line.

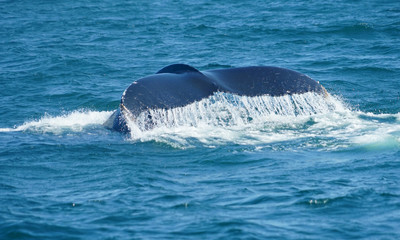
left=131, top=93, right=344, bottom=130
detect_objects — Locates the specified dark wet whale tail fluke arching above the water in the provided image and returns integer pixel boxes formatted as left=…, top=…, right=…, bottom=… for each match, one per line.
left=103, top=64, right=327, bottom=133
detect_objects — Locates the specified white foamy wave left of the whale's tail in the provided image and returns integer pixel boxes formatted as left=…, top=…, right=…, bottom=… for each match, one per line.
left=0, top=110, right=112, bottom=134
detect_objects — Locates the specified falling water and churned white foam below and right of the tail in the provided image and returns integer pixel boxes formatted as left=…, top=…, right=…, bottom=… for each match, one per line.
left=124, top=93, right=400, bottom=150
